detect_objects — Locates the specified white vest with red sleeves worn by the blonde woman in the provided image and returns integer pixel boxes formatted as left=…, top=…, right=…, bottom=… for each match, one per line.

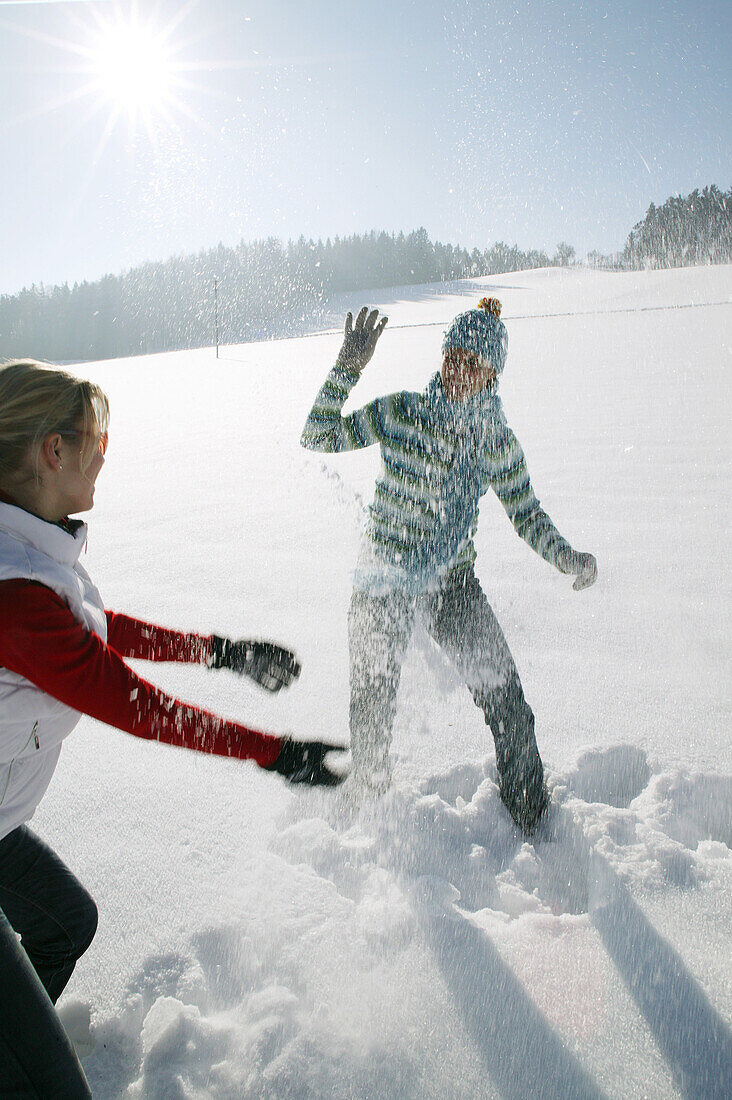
left=0, top=501, right=282, bottom=838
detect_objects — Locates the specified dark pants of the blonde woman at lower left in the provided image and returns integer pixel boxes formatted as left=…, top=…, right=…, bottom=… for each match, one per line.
left=0, top=825, right=97, bottom=1100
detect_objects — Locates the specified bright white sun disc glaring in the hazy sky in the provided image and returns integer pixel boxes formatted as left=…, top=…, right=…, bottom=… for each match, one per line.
left=90, top=21, right=173, bottom=116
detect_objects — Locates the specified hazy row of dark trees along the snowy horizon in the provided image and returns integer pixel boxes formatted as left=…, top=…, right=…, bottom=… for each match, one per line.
left=0, top=187, right=732, bottom=362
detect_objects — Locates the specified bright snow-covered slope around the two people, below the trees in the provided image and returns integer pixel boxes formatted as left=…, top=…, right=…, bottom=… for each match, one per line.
left=34, top=267, right=732, bottom=1100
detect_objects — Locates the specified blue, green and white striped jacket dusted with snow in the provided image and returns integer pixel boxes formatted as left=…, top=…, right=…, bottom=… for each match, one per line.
left=301, top=364, right=571, bottom=591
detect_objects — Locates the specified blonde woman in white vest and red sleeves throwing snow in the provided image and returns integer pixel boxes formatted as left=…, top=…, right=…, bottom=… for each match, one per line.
left=0, top=361, right=342, bottom=1100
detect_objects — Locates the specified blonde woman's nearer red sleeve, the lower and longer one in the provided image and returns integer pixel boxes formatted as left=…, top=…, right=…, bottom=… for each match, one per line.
left=0, top=581, right=282, bottom=767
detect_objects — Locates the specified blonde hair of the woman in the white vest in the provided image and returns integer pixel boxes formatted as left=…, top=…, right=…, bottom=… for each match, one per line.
left=0, top=359, right=109, bottom=485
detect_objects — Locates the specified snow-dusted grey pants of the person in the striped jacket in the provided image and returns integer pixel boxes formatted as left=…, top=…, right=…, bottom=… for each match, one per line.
left=349, top=569, right=547, bottom=831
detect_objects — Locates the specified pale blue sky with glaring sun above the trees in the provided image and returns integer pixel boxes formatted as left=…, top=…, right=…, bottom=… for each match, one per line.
left=0, top=0, right=732, bottom=294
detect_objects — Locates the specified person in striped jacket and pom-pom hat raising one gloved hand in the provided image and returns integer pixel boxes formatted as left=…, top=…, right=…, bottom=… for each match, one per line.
left=302, top=298, right=597, bottom=835
